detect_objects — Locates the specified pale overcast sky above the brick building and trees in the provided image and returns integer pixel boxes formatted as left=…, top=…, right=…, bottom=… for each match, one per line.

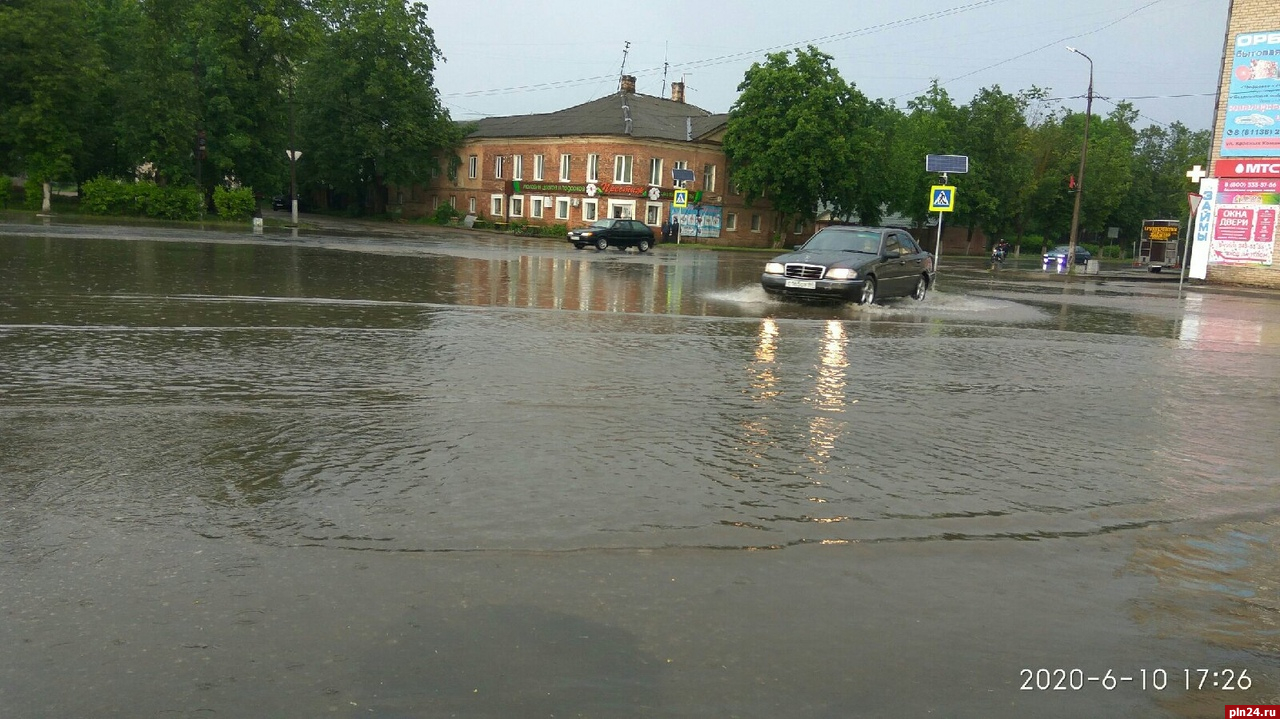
left=428, top=0, right=1228, bottom=129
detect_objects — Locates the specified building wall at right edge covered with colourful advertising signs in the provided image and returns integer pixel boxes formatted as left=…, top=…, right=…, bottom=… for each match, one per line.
left=1193, top=0, right=1280, bottom=287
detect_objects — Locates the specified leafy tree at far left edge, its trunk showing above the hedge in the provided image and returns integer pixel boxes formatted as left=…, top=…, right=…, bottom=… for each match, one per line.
left=0, top=0, right=104, bottom=211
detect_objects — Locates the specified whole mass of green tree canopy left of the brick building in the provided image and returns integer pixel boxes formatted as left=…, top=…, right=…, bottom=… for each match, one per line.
left=0, top=0, right=461, bottom=210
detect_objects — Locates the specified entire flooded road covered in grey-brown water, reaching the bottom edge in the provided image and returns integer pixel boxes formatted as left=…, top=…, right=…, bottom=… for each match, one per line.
left=0, top=224, right=1280, bottom=718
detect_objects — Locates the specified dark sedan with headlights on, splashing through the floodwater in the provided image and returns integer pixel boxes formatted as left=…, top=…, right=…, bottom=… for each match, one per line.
left=760, top=225, right=933, bottom=304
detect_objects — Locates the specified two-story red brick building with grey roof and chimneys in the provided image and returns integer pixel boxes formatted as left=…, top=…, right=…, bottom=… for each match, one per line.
left=401, top=75, right=778, bottom=247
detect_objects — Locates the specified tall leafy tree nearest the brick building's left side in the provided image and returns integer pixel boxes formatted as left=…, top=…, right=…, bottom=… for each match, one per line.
left=297, top=0, right=462, bottom=212
